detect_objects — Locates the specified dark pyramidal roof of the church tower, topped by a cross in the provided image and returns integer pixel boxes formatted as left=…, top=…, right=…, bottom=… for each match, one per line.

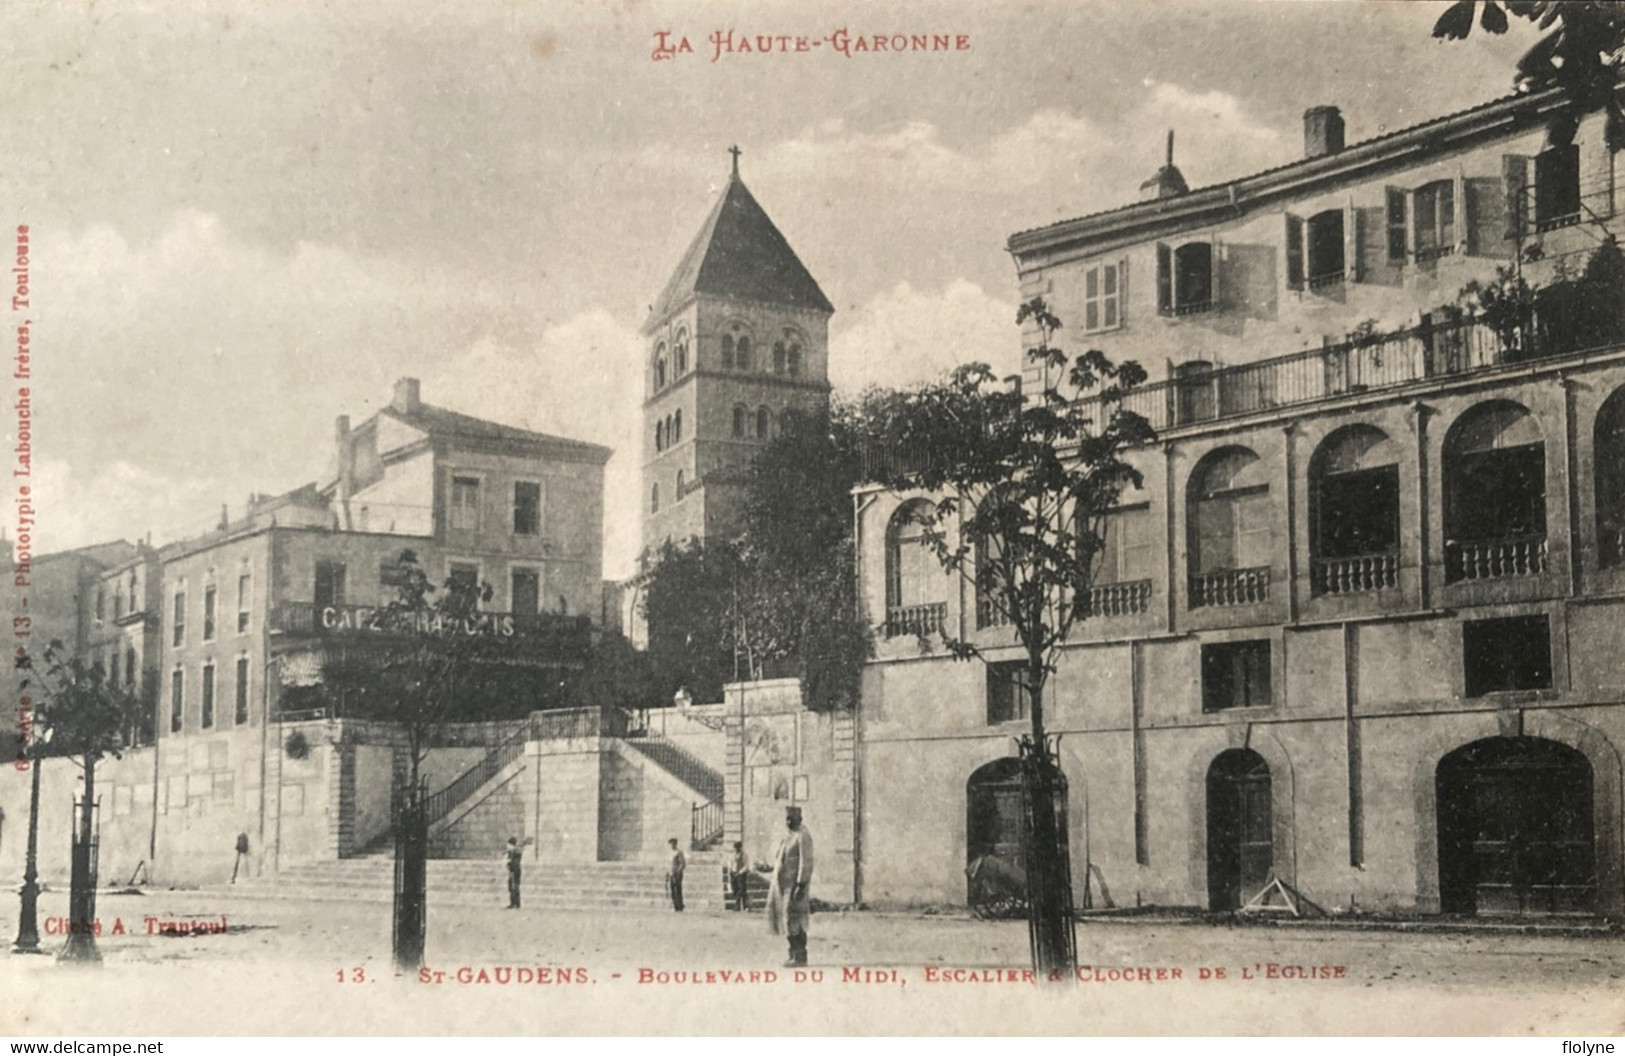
left=644, top=153, right=835, bottom=330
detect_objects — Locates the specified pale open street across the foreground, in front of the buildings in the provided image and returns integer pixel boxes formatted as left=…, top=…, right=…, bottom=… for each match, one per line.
left=0, top=890, right=1625, bottom=1033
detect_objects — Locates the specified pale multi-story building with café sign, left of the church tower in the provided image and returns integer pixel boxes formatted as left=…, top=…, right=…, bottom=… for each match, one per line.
left=0, top=379, right=609, bottom=881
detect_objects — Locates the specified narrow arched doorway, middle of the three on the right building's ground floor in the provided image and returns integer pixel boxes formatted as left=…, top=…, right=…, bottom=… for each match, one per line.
left=1207, top=747, right=1276, bottom=910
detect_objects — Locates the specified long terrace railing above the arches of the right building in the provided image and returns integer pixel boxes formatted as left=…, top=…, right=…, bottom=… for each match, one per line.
left=863, top=310, right=1625, bottom=479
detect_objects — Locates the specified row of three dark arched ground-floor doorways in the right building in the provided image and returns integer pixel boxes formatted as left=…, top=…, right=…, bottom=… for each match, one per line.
left=965, top=736, right=1601, bottom=915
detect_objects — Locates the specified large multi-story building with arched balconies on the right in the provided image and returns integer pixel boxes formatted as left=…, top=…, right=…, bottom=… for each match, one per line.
left=858, top=84, right=1625, bottom=913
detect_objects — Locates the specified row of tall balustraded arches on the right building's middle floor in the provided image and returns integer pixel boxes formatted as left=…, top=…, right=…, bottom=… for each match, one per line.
left=886, top=390, right=1625, bottom=623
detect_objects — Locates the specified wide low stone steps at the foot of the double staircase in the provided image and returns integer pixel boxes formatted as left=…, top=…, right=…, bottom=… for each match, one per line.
left=219, top=853, right=747, bottom=911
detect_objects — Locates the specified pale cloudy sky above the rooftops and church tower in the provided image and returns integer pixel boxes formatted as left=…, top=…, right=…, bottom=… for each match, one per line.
left=0, top=0, right=1532, bottom=578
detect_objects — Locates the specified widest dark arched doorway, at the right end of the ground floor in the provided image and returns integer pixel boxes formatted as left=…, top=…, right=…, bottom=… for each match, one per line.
left=1435, top=738, right=1597, bottom=913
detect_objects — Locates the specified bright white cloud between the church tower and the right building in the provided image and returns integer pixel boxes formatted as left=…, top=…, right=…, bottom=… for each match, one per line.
left=829, top=279, right=1021, bottom=392
